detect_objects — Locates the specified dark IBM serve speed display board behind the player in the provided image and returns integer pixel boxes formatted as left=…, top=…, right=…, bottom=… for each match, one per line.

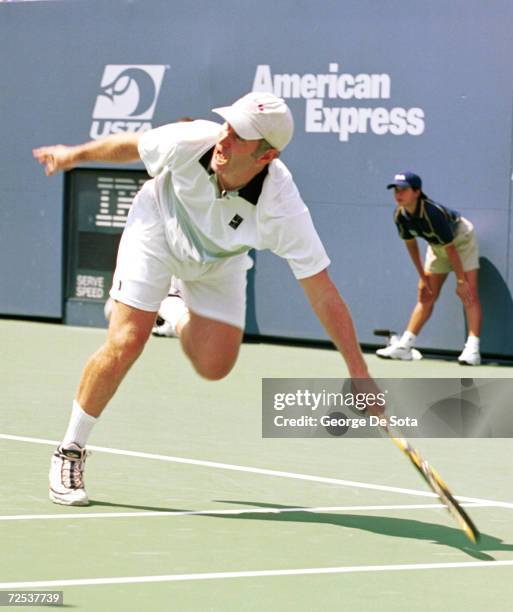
left=64, top=168, right=150, bottom=327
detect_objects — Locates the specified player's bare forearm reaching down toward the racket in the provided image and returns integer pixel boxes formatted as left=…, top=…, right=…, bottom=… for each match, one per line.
left=299, top=270, right=370, bottom=379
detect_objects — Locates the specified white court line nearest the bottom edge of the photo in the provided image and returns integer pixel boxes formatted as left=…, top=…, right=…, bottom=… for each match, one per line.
left=0, top=559, right=513, bottom=589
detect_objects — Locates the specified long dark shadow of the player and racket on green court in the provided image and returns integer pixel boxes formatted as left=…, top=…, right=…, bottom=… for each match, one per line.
left=91, top=499, right=513, bottom=561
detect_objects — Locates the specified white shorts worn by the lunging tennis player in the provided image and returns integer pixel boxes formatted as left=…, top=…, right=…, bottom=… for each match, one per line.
left=110, top=185, right=253, bottom=329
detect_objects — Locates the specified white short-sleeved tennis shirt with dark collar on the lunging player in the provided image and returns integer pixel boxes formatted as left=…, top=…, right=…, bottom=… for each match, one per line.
left=139, top=120, right=330, bottom=279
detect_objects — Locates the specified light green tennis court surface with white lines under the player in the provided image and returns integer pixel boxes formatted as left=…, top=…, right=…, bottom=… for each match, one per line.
left=0, top=320, right=513, bottom=612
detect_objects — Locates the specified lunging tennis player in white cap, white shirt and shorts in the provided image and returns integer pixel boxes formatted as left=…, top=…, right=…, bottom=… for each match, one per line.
left=33, top=93, right=369, bottom=505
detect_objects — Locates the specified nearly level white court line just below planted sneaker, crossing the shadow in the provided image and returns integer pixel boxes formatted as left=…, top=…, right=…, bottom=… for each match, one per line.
left=0, top=503, right=492, bottom=521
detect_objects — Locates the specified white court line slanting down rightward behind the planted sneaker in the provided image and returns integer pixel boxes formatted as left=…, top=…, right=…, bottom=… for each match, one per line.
left=0, top=434, right=513, bottom=508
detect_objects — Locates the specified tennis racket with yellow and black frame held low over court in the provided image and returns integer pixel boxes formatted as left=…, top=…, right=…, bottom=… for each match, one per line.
left=385, top=428, right=480, bottom=544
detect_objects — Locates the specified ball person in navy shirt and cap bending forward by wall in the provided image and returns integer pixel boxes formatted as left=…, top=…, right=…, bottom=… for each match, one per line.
left=376, top=172, right=481, bottom=365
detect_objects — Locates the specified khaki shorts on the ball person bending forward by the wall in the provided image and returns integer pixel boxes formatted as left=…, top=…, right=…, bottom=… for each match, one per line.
left=424, top=217, right=479, bottom=274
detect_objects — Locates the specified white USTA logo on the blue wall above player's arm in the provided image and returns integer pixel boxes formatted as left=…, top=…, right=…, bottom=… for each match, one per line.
left=90, top=64, right=169, bottom=139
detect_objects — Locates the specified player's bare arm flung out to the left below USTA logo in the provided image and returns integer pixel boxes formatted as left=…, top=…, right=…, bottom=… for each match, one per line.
left=32, top=132, right=141, bottom=176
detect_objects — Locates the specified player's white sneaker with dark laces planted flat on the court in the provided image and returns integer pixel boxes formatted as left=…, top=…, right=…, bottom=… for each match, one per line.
left=49, top=444, right=89, bottom=506
